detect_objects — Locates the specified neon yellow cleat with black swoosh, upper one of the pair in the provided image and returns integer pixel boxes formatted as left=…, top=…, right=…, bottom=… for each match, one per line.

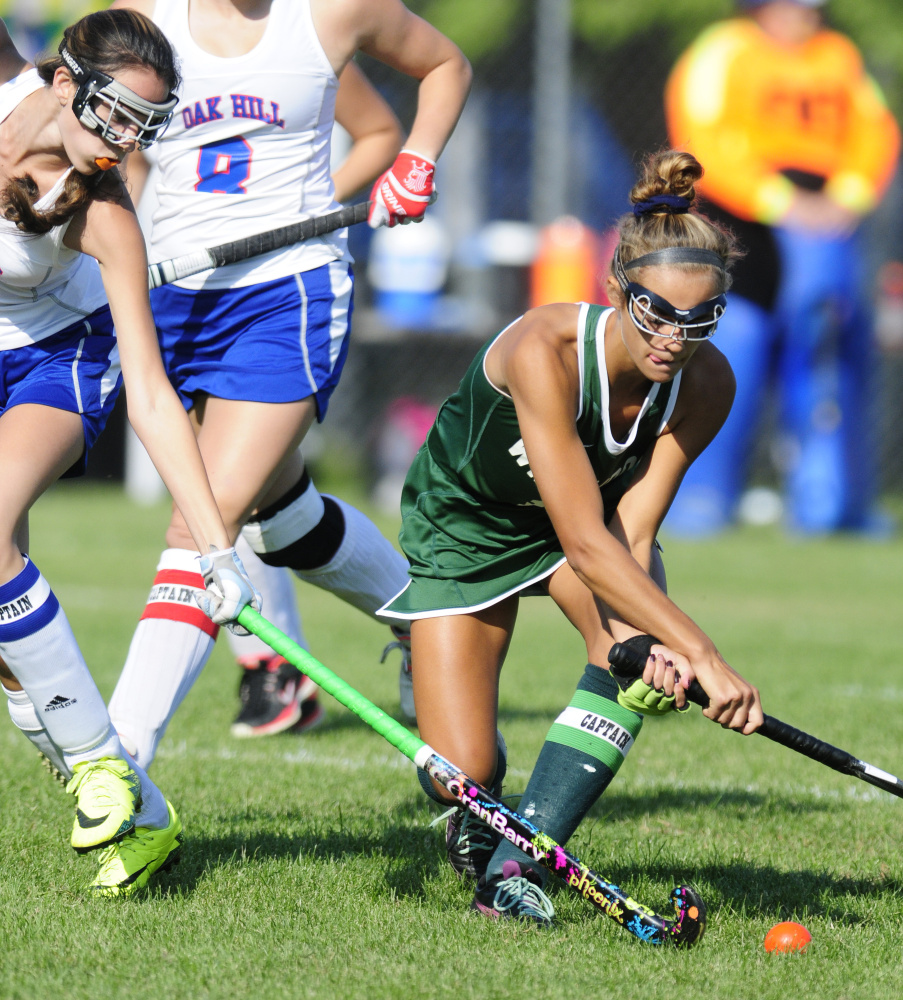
left=66, top=757, right=141, bottom=854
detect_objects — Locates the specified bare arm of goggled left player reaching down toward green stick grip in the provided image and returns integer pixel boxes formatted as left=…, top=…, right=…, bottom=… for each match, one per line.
left=65, top=181, right=232, bottom=553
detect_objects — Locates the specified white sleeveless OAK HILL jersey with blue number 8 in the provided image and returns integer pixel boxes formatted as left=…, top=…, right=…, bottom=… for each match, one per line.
left=150, top=0, right=351, bottom=289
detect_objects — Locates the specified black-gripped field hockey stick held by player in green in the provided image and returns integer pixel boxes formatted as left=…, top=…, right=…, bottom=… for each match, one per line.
left=608, top=642, right=903, bottom=798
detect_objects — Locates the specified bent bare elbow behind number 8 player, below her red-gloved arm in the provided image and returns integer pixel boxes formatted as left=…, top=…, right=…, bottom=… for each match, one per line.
left=332, top=62, right=402, bottom=201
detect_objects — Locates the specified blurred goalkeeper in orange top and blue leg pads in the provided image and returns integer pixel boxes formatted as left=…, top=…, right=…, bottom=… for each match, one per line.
left=665, top=0, right=900, bottom=535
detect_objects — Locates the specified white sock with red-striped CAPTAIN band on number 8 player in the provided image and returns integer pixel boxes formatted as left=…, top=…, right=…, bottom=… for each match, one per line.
left=110, top=549, right=218, bottom=768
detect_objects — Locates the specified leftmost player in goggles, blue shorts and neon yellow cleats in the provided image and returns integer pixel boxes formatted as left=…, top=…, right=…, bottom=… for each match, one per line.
left=0, top=11, right=253, bottom=895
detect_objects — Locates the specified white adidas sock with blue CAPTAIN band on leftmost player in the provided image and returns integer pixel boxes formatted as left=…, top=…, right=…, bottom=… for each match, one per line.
left=0, top=557, right=121, bottom=770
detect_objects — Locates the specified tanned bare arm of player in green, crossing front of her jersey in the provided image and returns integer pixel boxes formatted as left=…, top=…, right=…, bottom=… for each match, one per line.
left=497, top=305, right=762, bottom=732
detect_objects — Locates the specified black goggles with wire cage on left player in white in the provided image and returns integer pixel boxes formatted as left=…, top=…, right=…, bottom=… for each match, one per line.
left=60, top=45, right=179, bottom=149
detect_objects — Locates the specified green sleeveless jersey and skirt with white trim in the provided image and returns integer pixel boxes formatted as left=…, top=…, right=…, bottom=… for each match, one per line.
left=381, top=303, right=680, bottom=618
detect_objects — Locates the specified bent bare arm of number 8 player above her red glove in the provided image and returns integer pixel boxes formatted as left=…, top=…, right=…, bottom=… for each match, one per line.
left=311, top=0, right=472, bottom=160
